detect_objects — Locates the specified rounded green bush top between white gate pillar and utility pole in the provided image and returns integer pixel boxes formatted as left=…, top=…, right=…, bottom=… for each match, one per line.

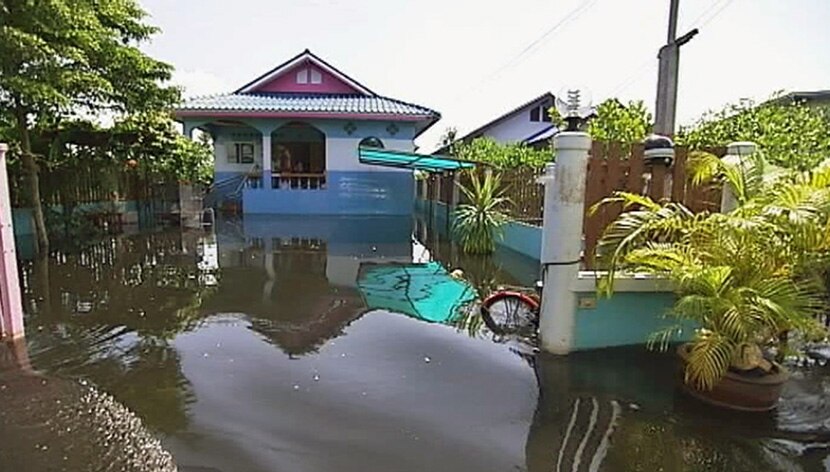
left=588, top=98, right=651, bottom=143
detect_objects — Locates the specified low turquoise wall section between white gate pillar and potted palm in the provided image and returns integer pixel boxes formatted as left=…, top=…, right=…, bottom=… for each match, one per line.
left=573, top=292, right=694, bottom=350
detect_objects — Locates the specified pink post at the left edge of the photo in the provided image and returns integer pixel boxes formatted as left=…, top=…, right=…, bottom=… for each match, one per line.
left=0, top=143, right=24, bottom=339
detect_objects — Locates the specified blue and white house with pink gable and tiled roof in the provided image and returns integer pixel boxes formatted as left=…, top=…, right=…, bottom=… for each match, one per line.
left=175, top=50, right=440, bottom=215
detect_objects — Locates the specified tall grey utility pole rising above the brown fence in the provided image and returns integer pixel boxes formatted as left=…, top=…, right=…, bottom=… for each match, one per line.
left=654, top=0, right=698, bottom=136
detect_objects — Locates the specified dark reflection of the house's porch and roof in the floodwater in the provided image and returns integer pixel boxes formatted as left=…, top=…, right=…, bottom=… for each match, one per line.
left=202, top=238, right=365, bottom=355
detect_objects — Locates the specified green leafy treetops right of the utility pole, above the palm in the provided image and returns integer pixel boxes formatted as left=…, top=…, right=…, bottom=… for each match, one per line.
left=677, top=99, right=830, bottom=170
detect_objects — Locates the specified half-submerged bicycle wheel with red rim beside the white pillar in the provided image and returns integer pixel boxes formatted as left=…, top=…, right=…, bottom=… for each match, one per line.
left=481, top=291, right=539, bottom=334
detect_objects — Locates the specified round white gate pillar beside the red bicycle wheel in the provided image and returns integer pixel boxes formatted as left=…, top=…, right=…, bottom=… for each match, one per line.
left=539, top=131, right=591, bottom=354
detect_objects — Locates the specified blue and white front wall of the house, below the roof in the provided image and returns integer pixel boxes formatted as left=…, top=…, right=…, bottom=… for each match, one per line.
left=190, top=119, right=422, bottom=215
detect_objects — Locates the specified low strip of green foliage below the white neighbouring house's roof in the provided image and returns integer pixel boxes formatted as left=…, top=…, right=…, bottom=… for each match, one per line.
left=453, top=137, right=553, bottom=169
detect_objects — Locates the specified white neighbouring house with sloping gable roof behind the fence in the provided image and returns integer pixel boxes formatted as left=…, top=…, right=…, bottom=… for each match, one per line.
left=437, top=92, right=559, bottom=154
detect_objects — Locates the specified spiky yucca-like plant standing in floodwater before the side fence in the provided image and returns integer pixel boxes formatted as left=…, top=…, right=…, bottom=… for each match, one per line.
left=453, top=172, right=509, bottom=254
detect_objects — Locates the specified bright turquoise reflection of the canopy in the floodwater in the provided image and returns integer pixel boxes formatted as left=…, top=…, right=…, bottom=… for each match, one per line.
left=357, top=262, right=476, bottom=323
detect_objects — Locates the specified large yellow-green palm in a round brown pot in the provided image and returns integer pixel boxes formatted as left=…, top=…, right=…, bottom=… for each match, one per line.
left=598, top=156, right=830, bottom=411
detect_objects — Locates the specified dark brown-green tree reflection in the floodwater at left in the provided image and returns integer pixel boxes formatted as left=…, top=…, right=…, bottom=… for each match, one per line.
left=22, top=232, right=214, bottom=433
